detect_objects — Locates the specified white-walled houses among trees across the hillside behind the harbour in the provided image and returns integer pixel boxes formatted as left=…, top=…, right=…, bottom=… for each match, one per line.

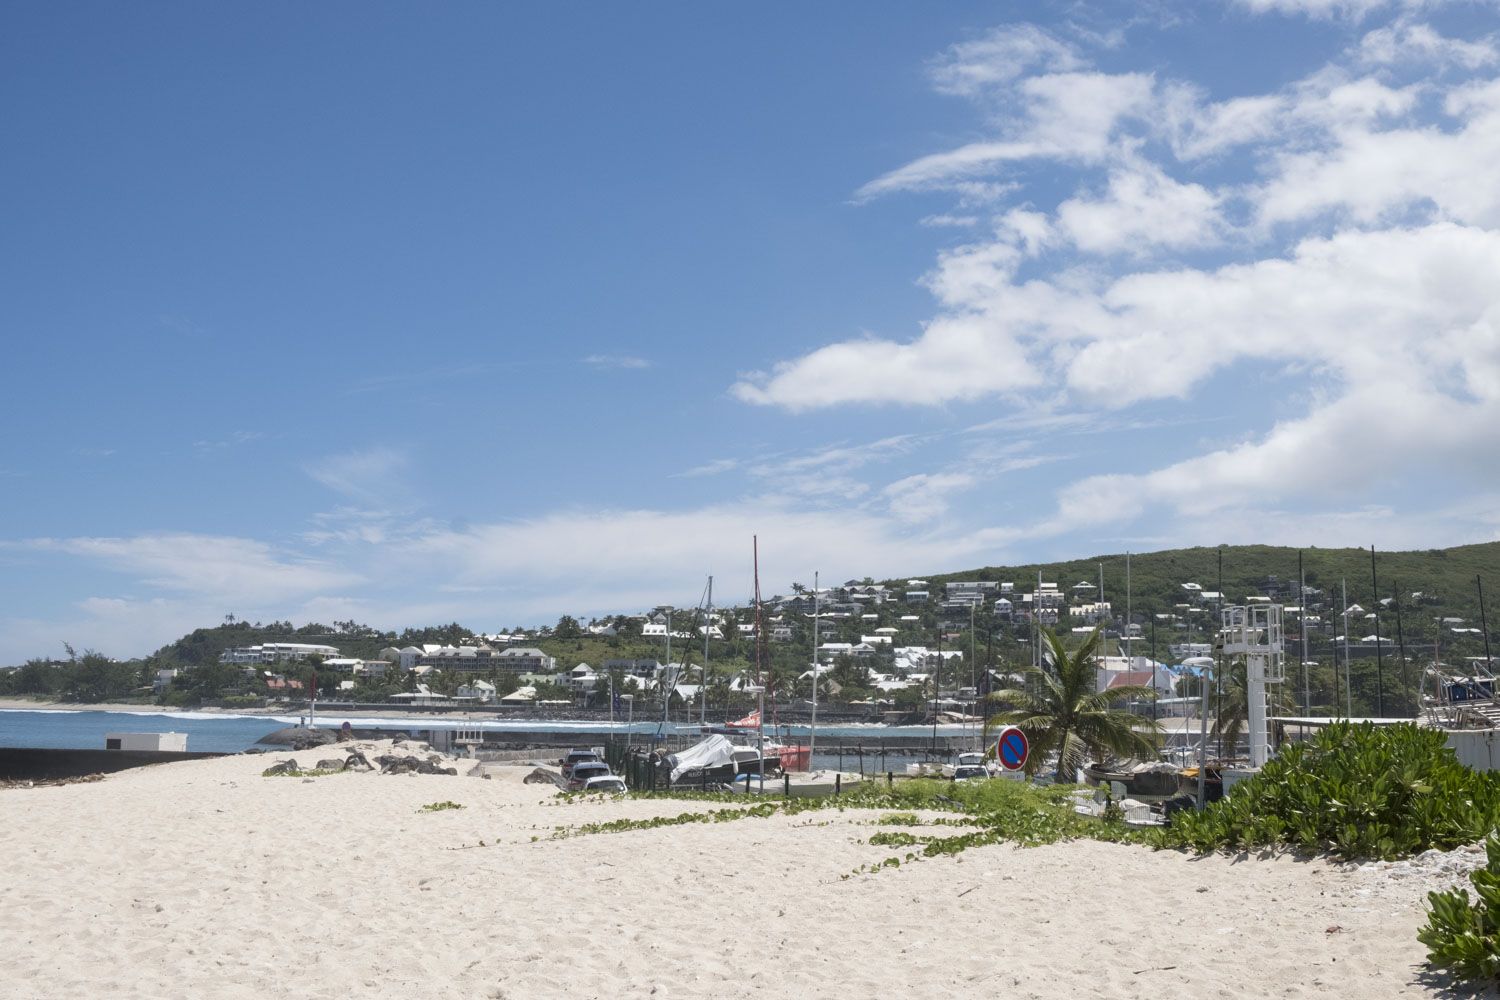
left=17, top=564, right=1490, bottom=721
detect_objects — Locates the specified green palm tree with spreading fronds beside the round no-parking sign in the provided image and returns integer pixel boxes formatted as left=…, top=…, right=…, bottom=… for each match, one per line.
left=984, top=628, right=1160, bottom=781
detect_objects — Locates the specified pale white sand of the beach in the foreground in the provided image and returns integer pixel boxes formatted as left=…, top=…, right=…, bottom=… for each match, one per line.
left=0, top=748, right=1482, bottom=1000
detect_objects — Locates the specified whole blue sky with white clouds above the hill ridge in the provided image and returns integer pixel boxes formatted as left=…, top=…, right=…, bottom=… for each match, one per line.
left=0, top=0, right=1500, bottom=663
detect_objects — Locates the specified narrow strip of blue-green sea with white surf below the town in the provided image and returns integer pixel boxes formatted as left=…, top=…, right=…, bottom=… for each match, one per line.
left=0, top=709, right=975, bottom=755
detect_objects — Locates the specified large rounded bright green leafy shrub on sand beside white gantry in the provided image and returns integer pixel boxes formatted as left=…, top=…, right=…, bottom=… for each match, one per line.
left=1167, top=723, right=1500, bottom=861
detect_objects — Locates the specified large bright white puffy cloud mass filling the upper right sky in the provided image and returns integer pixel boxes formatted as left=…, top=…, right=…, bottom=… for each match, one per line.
left=732, top=0, right=1500, bottom=551
